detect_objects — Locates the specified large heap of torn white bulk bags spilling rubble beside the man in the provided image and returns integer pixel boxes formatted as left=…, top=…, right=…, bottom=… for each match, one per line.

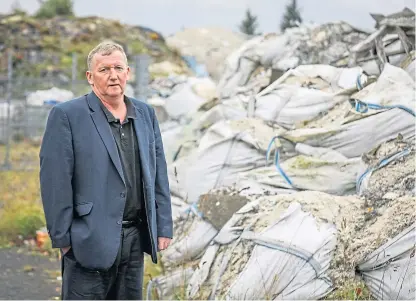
left=147, top=8, right=416, bottom=300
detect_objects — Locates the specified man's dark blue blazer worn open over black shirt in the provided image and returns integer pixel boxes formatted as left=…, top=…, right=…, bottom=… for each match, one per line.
left=39, top=92, right=173, bottom=269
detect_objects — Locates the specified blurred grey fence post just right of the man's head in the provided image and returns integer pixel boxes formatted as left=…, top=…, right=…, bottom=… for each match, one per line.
left=134, top=54, right=150, bottom=102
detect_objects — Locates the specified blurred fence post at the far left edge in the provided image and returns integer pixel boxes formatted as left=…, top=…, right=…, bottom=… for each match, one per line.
left=2, top=49, right=13, bottom=170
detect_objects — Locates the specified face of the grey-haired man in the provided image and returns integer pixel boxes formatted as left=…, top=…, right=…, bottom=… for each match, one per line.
left=87, top=51, right=130, bottom=98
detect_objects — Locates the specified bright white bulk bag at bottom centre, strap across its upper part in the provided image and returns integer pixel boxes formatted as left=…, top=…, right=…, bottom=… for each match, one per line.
left=226, top=203, right=336, bottom=300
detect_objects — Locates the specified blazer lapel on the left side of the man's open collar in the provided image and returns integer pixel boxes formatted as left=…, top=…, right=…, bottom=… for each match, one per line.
left=87, top=92, right=125, bottom=184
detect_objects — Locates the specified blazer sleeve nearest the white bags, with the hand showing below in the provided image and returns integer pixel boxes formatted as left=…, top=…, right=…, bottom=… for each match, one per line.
left=151, top=108, right=173, bottom=238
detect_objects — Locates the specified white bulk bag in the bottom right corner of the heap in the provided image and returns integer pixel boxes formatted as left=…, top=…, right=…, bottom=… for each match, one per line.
left=357, top=223, right=416, bottom=300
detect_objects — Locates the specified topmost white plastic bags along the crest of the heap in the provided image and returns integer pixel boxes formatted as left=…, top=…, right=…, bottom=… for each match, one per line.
left=218, top=22, right=367, bottom=98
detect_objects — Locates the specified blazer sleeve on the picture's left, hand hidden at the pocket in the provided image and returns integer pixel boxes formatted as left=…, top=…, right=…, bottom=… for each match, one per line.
left=39, top=106, right=74, bottom=248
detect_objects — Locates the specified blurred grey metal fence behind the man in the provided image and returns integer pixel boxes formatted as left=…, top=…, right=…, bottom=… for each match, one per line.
left=0, top=51, right=151, bottom=170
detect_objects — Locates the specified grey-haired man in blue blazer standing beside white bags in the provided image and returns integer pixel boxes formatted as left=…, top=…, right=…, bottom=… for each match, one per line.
left=40, top=42, right=173, bottom=299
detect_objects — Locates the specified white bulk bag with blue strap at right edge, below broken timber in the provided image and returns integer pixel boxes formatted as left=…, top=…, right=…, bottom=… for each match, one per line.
left=272, top=64, right=415, bottom=158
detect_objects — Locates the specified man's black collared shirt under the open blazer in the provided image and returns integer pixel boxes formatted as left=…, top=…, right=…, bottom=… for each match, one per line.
left=101, top=97, right=143, bottom=221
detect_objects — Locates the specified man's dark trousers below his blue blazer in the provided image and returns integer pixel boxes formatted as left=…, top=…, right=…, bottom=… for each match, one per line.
left=62, top=226, right=144, bottom=300
